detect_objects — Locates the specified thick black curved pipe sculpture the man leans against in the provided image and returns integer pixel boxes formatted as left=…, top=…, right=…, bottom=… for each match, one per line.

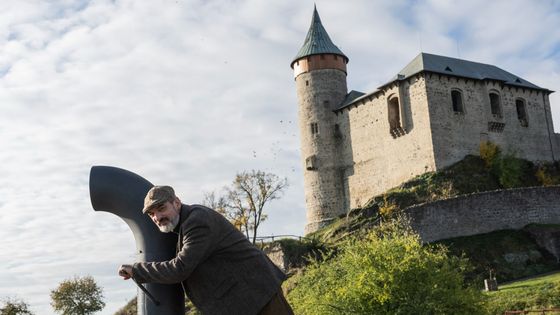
left=89, top=166, right=185, bottom=315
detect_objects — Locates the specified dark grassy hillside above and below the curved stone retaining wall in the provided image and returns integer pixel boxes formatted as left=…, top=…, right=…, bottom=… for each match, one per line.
left=294, top=153, right=560, bottom=284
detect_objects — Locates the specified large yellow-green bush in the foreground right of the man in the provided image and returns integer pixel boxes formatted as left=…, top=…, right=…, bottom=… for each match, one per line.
left=288, top=221, right=484, bottom=315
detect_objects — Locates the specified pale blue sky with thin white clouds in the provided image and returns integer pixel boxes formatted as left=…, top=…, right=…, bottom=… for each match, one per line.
left=0, top=0, right=560, bottom=315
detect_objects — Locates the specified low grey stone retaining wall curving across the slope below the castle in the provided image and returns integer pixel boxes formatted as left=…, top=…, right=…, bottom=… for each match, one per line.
left=405, top=186, right=560, bottom=242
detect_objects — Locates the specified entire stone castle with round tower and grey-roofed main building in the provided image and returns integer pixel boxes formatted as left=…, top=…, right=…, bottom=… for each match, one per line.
left=291, top=9, right=560, bottom=233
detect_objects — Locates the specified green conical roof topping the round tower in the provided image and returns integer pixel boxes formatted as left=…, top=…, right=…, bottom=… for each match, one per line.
left=291, top=7, right=348, bottom=65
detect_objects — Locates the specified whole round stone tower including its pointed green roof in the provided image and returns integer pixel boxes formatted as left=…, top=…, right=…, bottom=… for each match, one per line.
left=290, top=8, right=348, bottom=233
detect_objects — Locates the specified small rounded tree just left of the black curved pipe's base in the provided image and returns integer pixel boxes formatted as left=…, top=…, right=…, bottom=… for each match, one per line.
left=51, top=276, right=105, bottom=315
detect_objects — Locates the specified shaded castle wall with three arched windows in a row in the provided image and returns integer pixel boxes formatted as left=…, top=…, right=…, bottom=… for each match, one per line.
left=426, top=74, right=555, bottom=169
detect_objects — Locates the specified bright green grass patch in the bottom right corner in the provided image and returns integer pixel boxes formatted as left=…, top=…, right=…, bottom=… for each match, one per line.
left=486, top=272, right=560, bottom=314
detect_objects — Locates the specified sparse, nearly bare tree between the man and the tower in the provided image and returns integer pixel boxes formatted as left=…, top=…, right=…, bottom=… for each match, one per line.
left=203, top=170, right=288, bottom=244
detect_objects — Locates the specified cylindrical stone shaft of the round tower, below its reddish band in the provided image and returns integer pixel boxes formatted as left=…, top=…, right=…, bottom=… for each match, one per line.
left=295, top=69, right=347, bottom=233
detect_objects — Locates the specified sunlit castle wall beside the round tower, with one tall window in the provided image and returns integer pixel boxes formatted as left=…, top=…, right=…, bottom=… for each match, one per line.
left=337, top=75, right=435, bottom=209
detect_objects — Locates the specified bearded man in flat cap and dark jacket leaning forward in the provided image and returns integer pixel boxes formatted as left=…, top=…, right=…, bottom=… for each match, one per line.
left=119, top=186, right=293, bottom=315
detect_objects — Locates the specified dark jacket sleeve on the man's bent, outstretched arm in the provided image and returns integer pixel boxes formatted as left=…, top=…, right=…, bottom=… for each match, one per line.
left=132, top=215, right=214, bottom=284
